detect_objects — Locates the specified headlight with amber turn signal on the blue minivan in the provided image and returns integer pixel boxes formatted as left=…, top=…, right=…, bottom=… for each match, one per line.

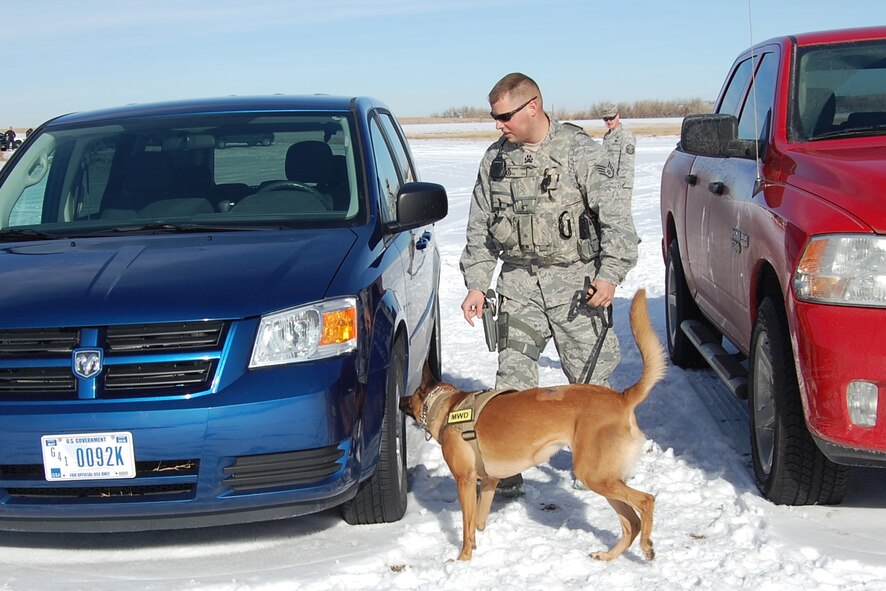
left=249, top=297, right=357, bottom=368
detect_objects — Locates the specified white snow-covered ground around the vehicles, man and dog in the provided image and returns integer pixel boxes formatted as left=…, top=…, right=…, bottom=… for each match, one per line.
left=0, top=131, right=886, bottom=591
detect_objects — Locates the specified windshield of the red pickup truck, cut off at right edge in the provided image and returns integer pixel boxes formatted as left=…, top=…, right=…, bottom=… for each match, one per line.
left=789, top=40, right=886, bottom=141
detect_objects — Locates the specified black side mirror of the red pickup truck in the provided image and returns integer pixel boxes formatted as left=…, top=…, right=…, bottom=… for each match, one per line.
left=680, top=115, right=758, bottom=160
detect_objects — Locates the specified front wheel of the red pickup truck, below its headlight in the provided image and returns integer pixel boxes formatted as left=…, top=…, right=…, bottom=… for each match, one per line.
left=748, top=298, right=849, bottom=505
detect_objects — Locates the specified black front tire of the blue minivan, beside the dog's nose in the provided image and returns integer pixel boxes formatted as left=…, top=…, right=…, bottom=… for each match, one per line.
left=342, top=339, right=406, bottom=525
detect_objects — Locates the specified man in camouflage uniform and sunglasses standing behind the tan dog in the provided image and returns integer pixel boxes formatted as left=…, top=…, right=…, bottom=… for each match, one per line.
left=460, top=73, right=639, bottom=389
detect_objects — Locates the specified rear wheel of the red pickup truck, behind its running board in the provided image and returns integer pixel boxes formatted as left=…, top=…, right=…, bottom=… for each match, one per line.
left=665, top=240, right=707, bottom=368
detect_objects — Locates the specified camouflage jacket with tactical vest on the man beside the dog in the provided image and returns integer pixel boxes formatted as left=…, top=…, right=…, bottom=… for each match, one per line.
left=460, top=120, right=639, bottom=304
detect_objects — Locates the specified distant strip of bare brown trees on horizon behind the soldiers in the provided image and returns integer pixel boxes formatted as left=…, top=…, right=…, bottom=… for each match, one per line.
left=431, top=98, right=714, bottom=120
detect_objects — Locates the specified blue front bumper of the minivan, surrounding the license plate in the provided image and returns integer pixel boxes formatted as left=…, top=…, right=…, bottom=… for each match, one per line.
left=0, top=356, right=375, bottom=532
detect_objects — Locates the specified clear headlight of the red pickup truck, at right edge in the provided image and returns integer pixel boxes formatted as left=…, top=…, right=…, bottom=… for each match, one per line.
left=794, top=234, right=886, bottom=307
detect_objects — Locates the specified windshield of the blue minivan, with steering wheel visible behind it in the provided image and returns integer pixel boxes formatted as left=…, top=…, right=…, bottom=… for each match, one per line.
left=0, top=112, right=365, bottom=241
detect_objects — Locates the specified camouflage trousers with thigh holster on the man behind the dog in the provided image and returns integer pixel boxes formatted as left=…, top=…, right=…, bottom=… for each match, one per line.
left=495, top=293, right=621, bottom=390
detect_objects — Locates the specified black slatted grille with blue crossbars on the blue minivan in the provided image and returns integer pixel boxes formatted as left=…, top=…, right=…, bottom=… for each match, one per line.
left=0, top=321, right=227, bottom=402
